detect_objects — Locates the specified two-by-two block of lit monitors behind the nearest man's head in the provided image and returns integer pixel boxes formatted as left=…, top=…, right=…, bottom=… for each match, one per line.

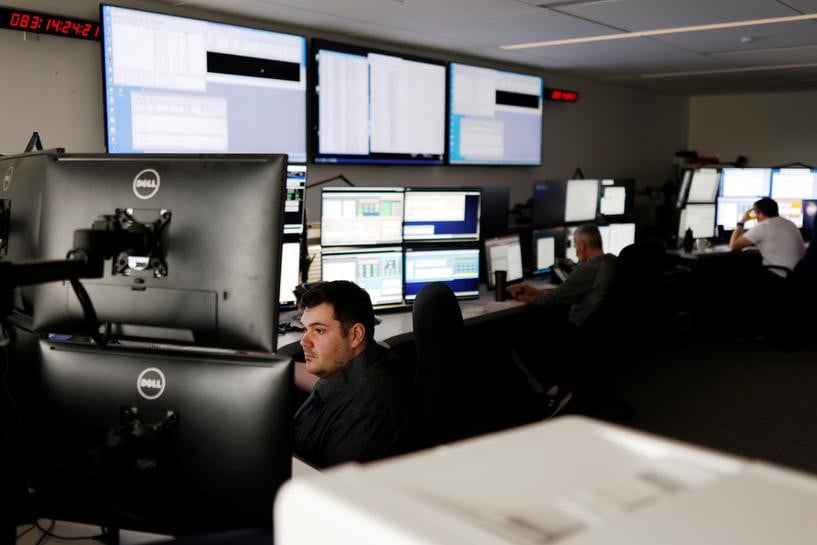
left=321, top=188, right=481, bottom=308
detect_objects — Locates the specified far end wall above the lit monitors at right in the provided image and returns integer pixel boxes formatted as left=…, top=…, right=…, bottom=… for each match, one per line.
left=689, top=91, right=817, bottom=166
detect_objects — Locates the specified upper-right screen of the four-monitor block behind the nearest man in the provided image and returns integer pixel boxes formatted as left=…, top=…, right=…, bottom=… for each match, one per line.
left=403, top=187, right=480, bottom=242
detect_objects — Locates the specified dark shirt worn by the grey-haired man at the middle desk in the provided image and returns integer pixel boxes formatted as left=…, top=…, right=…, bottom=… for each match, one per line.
left=534, top=254, right=616, bottom=329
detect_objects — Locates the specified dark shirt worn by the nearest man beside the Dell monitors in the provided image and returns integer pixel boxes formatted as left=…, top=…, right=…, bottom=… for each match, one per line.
left=295, top=342, right=409, bottom=467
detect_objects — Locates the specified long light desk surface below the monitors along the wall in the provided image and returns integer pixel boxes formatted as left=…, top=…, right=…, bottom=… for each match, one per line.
left=278, top=279, right=555, bottom=355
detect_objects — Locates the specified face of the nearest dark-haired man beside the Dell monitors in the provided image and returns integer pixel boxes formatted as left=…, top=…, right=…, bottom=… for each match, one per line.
left=301, top=303, right=363, bottom=378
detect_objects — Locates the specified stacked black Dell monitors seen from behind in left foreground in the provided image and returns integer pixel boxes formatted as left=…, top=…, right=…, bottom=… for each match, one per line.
left=0, top=151, right=293, bottom=533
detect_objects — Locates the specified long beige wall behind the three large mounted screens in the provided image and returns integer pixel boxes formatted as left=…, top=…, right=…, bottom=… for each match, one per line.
left=0, top=0, right=688, bottom=218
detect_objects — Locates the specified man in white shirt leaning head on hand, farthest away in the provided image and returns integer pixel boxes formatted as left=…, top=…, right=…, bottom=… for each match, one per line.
left=729, top=197, right=805, bottom=278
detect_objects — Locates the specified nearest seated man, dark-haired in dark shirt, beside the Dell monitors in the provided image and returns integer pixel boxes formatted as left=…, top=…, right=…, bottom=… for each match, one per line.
left=294, top=281, right=409, bottom=467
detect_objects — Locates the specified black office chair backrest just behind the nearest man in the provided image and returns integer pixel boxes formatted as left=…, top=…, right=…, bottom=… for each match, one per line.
left=412, top=282, right=465, bottom=448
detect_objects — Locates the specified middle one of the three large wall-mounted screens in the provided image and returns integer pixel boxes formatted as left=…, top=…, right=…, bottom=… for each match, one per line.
left=312, top=40, right=445, bottom=165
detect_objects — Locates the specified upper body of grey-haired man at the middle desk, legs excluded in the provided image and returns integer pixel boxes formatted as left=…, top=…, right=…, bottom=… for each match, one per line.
left=508, top=224, right=616, bottom=331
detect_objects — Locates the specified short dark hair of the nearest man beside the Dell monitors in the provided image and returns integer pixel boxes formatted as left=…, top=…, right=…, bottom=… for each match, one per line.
left=299, top=280, right=374, bottom=341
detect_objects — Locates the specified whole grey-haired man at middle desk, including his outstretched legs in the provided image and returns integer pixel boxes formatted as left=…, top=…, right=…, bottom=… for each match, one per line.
left=508, top=224, right=617, bottom=415
